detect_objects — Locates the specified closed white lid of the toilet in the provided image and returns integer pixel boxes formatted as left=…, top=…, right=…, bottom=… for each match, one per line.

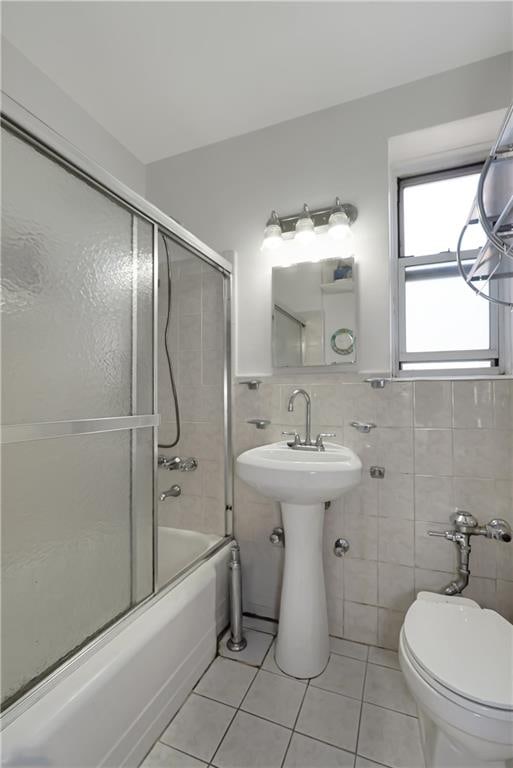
left=404, top=598, right=513, bottom=710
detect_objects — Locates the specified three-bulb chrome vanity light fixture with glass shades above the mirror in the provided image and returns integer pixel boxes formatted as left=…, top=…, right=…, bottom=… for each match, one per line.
left=262, top=197, right=358, bottom=250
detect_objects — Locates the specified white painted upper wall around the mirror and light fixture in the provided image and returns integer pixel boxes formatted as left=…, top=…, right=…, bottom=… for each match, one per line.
left=147, top=54, right=513, bottom=375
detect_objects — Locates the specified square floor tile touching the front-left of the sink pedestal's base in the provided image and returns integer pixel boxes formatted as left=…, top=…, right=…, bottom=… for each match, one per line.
left=241, top=669, right=306, bottom=728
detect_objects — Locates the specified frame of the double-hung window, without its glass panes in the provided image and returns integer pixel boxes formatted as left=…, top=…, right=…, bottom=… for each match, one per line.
left=393, top=162, right=503, bottom=378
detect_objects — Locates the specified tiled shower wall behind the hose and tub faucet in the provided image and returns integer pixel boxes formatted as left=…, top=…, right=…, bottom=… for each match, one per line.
left=158, top=249, right=225, bottom=536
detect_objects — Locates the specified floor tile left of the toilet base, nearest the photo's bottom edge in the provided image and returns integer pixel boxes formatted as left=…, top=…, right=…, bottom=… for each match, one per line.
left=358, top=704, right=424, bottom=768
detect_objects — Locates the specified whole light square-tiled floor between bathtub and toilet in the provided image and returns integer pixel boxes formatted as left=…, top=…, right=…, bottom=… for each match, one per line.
left=141, top=623, right=424, bottom=768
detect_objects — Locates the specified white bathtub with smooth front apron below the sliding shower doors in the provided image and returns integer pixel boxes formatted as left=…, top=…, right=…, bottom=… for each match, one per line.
left=2, top=528, right=230, bottom=768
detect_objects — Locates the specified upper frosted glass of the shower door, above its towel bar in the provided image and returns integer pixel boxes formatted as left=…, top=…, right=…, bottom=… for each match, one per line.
left=2, top=129, right=152, bottom=424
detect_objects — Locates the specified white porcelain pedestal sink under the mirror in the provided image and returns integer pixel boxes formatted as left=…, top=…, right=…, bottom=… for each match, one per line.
left=236, top=442, right=362, bottom=678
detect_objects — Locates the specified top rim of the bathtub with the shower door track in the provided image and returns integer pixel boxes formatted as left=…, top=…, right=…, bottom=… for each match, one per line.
left=0, top=534, right=234, bottom=733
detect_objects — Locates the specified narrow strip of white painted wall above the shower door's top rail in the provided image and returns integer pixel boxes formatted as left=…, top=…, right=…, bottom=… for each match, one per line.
left=1, top=38, right=146, bottom=195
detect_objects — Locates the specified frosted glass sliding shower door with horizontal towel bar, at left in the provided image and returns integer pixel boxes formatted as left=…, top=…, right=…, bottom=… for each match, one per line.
left=1, top=126, right=157, bottom=706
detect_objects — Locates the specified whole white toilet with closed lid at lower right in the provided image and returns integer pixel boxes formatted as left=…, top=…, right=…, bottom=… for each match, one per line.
left=399, top=592, right=513, bottom=768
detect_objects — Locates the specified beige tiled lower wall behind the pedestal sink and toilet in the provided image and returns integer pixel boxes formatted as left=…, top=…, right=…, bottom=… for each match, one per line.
left=234, top=375, right=513, bottom=648
